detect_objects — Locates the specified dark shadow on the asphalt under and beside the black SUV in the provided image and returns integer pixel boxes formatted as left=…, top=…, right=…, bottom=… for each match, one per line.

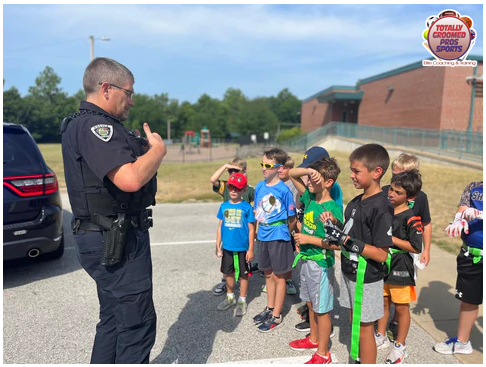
left=3, top=210, right=81, bottom=289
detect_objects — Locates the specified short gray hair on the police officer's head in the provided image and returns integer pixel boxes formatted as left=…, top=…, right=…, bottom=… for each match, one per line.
left=83, top=57, right=135, bottom=96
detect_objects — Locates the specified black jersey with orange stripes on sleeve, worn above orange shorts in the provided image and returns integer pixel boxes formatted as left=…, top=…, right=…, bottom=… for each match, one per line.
left=385, top=209, right=423, bottom=285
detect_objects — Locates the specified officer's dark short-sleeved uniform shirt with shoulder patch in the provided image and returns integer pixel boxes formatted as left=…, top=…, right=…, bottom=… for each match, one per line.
left=62, top=101, right=136, bottom=217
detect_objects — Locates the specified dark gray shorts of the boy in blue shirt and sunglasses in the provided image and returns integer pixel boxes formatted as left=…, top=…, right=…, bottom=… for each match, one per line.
left=257, top=240, right=294, bottom=274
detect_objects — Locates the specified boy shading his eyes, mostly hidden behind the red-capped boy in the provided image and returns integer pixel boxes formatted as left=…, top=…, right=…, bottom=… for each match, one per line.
left=210, top=157, right=255, bottom=296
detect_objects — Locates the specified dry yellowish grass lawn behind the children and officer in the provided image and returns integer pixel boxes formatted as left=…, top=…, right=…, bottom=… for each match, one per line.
left=39, top=144, right=483, bottom=253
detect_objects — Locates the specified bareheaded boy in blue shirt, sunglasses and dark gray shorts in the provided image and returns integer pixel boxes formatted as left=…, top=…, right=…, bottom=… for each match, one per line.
left=253, top=148, right=296, bottom=333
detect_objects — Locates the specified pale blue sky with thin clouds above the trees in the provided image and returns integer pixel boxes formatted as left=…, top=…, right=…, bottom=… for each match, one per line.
left=3, top=4, right=483, bottom=103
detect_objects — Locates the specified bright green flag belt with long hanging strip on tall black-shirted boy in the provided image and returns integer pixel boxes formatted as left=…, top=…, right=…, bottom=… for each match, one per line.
left=341, top=247, right=391, bottom=361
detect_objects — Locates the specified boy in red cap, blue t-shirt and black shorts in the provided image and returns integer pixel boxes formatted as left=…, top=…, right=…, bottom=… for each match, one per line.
left=216, top=173, right=255, bottom=316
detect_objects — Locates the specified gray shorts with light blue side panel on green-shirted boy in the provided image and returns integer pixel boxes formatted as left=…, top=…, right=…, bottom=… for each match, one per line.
left=300, top=260, right=334, bottom=314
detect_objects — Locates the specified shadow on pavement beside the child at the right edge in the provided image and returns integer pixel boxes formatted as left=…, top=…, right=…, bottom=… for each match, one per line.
left=412, top=281, right=483, bottom=353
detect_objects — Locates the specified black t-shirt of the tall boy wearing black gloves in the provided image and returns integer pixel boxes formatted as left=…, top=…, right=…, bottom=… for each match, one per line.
left=341, top=192, right=393, bottom=283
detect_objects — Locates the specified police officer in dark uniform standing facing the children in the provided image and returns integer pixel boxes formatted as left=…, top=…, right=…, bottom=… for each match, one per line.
left=61, top=58, right=167, bottom=363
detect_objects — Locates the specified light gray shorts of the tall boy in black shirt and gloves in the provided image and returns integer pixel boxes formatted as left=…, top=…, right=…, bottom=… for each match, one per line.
left=339, top=273, right=384, bottom=322
